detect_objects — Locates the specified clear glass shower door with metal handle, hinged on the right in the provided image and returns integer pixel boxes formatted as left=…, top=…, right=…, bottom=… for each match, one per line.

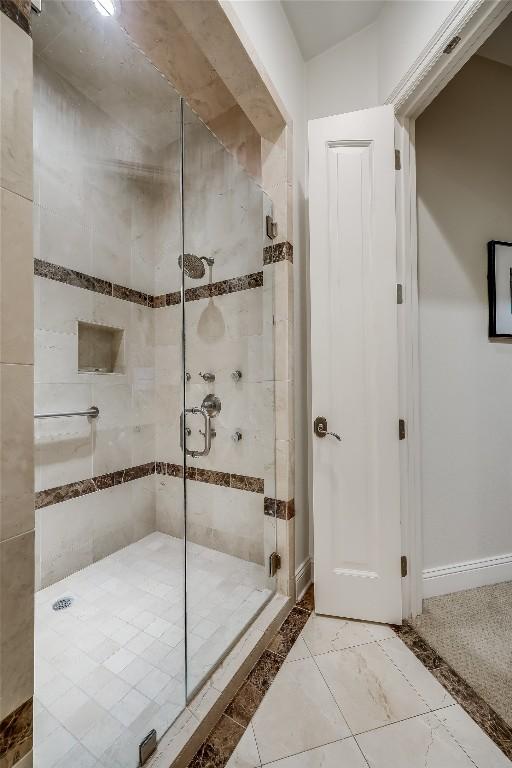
left=181, top=105, right=276, bottom=698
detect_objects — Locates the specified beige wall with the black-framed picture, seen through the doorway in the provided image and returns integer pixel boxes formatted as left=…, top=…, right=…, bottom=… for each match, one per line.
left=416, top=56, right=512, bottom=568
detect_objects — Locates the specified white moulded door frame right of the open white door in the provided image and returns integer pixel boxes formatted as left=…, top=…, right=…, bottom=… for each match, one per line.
left=385, top=0, right=512, bottom=619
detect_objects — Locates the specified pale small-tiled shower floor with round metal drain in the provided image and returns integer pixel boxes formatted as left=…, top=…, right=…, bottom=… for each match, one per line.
left=34, top=533, right=271, bottom=768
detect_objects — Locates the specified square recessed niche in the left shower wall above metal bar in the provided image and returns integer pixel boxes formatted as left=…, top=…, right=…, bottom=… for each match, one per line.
left=78, top=320, right=125, bottom=373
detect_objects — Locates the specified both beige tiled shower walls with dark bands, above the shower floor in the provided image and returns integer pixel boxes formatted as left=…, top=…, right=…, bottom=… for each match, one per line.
left=34, top=31, right=275, bottom=586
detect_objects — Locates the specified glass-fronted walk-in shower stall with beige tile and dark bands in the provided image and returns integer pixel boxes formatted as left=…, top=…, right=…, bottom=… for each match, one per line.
left=33, top=0, right=276, bottom=768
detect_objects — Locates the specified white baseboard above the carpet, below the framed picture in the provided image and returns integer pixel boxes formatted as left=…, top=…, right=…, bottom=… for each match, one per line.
left=423, top=552, right=512, bottom=598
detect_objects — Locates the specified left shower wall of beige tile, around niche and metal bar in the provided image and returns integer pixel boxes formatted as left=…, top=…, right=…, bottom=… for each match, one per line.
left=34, top=50, right=176, bottom=587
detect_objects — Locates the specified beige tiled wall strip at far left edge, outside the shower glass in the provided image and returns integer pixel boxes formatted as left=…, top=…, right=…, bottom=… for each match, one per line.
left=0, top=0, right=34, bottom=768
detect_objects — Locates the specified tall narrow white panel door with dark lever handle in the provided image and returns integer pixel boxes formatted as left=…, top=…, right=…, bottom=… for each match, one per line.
left=309, top=106, right=402, bottom=622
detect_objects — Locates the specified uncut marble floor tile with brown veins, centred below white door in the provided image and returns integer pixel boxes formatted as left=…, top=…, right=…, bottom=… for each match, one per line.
left=316, top=643, right=428, bottom=733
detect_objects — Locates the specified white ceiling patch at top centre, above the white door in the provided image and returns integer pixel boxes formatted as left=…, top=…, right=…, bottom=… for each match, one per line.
left=281, top=0, right=384, bottom=61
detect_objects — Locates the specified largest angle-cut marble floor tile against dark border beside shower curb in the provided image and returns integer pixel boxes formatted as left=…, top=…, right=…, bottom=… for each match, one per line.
left=253, top=659, right=350, bottom=763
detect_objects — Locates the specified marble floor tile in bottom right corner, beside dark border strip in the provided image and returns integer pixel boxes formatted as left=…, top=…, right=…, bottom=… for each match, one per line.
left=435, top=704, right=512, bottom=768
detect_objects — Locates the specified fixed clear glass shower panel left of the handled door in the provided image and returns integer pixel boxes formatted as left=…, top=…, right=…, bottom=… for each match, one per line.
left=32, top=0, right=186, bottom=768
